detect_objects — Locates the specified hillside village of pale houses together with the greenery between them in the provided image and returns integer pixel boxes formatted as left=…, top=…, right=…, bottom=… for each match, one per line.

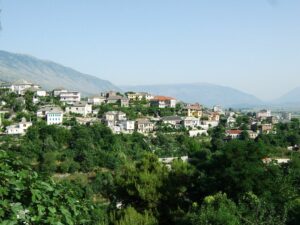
left=0, top=80, right=292, bottom=147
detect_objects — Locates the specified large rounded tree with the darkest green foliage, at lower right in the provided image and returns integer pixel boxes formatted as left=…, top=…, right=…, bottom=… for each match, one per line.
left=198, top=140, right=273, bottom=200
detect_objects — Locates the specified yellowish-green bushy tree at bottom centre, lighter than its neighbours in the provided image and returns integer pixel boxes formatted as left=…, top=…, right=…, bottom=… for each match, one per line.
left=115, top=154, right=167, bottom=213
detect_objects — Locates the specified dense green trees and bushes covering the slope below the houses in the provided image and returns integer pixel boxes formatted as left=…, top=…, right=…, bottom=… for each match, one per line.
left=0, top=88, right=300, bottom=225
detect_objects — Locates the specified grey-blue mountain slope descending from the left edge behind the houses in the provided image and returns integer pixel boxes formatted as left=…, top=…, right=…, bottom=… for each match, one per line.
left=0, top=51, right=119, bottom=95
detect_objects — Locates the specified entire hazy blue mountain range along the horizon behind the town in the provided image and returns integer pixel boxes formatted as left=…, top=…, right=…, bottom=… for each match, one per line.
left=0, top=51, right=300, bottom=107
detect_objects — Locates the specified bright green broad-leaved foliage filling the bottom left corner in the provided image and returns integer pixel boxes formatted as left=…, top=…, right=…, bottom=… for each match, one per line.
left=0, top=151, right=101, bottom=224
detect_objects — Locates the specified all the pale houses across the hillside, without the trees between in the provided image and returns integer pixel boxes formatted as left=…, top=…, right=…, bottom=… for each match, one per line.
left=0, top=80, right=291, bottom=139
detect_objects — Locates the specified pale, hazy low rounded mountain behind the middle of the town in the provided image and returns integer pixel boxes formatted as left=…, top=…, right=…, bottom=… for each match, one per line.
left=122, top=83, right=262, bottom=108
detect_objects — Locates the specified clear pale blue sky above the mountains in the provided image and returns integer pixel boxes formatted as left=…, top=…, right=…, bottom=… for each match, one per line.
left=0, top=0, right=300, bottom=100
